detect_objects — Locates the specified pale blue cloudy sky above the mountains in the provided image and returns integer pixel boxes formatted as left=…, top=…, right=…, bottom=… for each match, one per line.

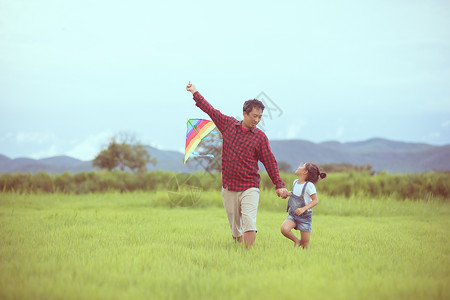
left=0, top=0, right=450, bottom=160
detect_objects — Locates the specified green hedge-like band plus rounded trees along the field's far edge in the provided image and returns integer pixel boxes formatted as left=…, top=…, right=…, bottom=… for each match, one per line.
left=0, top=134, right=450, bottom=201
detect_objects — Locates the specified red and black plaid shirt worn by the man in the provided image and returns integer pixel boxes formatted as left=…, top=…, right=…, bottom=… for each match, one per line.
left=194, top=92, right=285, bottom=192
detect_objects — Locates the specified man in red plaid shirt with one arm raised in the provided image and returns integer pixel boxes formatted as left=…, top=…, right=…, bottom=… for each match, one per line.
left=186, top=82, right=289, bottom=249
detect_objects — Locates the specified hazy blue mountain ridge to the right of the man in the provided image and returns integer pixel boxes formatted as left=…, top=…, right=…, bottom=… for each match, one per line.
left=270, top=138, right=450, bottom=173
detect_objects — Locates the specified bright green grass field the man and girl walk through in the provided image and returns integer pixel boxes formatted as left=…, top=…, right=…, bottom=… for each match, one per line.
left=0, top=192, right=450, bottom=299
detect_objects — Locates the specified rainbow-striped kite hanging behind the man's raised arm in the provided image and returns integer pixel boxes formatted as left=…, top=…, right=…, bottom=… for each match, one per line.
left=184, top=119, right=221, bottom=163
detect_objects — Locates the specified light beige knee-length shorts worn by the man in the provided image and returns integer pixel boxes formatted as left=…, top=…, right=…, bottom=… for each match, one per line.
left=222, top=187, right=259, bottom=237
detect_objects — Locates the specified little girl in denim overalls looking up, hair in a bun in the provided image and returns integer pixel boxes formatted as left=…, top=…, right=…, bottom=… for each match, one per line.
left=281, top=163, right=327, bottom=249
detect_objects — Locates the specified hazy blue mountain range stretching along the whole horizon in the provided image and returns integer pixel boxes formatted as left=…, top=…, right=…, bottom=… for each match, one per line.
left=0, top=138, right=450, bottom=173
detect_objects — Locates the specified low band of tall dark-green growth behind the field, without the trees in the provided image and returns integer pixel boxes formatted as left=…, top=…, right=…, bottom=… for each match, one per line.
left=0, top=171, right=450, bottom=201
